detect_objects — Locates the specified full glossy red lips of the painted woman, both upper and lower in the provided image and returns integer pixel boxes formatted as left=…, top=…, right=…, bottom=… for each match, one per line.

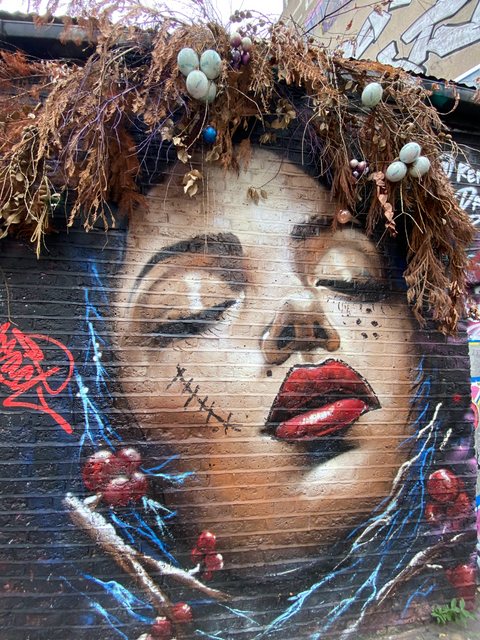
left=267, top=360, right=380, bottom=440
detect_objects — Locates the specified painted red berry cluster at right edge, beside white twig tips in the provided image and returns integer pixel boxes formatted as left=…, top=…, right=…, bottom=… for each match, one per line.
left=425, top=469, right=471, bottom=530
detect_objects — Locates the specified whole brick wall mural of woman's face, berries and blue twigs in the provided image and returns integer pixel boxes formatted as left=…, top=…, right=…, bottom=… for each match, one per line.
left=0, top=140, right=478, bottom=640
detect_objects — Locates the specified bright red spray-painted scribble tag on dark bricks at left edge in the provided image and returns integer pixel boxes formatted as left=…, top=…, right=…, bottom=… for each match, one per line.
left=0, top=322, right=73, bottom=433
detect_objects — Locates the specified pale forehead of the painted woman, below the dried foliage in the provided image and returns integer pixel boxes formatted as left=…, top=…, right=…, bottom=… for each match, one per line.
left=129, top=148, right=335, bottom=252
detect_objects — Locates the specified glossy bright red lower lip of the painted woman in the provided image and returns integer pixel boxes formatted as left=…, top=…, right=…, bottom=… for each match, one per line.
left=275, top=398, right=370, bottom=440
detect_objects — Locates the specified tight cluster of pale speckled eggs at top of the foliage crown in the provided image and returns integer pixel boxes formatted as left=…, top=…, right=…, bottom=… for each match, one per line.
left=177, top=47, right=222, bottom=104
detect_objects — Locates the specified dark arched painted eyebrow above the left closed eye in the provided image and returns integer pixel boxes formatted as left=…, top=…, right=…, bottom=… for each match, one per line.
left=130, top=233, right=246, bottom=301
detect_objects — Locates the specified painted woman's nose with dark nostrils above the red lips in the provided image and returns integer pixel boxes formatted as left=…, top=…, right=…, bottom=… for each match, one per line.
left=261, top=297, right=340, bottom=364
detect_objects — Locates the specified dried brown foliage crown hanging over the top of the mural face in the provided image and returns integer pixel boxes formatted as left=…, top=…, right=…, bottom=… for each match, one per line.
left=0, top=11, right=474, bottom=332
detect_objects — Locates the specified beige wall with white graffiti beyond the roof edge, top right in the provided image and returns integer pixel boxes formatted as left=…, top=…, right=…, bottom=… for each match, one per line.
left=283, top=0, right=480, bottom=87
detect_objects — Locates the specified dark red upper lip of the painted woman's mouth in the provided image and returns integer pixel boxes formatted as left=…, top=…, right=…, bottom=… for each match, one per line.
left=266, top=359, right=380, bottom=439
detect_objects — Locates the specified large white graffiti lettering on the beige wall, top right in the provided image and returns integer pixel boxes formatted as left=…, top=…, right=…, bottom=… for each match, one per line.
left=343, top=0, right=480, bottom=73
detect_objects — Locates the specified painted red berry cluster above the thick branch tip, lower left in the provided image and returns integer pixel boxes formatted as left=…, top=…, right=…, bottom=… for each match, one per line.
left=82, top=447, right=147, bottom=507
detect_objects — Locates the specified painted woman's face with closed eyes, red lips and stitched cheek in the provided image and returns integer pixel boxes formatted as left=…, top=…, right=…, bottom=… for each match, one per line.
left=114, top=149, right=418, bottom=574
